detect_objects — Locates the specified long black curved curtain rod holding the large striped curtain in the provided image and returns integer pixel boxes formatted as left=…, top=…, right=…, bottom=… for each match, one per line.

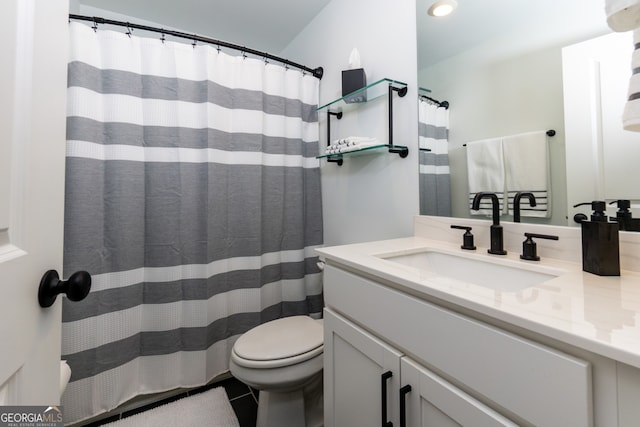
left=69, top=14, right=324, bottom=79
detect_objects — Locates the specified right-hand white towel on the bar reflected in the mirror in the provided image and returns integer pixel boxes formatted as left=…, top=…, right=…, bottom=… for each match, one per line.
left=502, top=131, right=551, bottom=218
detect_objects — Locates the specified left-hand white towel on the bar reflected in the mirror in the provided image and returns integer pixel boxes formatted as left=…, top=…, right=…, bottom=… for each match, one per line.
left=467, top=138, right=505, bottom=215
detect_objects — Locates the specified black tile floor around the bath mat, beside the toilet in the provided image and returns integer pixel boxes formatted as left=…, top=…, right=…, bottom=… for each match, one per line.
left=84, top=378, right=258, bottom=427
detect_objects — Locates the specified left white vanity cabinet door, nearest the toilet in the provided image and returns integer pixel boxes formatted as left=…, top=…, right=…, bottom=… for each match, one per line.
left=324, top=309, right=402, bottom=427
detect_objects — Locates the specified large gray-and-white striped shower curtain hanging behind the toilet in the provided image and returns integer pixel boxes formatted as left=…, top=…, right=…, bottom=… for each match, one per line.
left=62, top=23, right=323, bottom=422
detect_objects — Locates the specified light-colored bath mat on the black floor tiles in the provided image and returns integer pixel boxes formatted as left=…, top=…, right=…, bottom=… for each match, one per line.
left=104, top=387, right=240, bottom=427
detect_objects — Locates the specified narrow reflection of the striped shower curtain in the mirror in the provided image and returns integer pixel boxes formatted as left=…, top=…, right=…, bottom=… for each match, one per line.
left=418, top=98, right=451, bottom=216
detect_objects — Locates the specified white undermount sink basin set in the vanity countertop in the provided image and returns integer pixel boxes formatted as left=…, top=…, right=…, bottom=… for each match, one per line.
left=378, top=250, right=561, bottom=292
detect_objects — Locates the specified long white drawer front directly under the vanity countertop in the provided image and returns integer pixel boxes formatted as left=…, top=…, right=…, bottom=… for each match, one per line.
left=324, top=265, right=593, bottom=427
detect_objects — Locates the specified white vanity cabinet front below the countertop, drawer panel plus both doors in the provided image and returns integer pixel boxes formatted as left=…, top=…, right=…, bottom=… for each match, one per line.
left=324, top=262, right=593, bottom=427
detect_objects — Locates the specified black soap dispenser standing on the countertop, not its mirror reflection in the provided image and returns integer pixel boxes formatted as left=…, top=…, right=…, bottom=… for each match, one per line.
left=574, top=200, right=620, bottom=276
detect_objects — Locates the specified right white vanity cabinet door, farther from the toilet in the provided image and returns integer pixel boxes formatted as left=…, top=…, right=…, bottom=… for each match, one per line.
left=400, top=357, right=517, bottom=427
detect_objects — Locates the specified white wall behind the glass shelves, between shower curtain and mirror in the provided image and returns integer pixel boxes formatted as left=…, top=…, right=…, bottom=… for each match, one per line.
left=282, top=0, right=418, bottom=245
